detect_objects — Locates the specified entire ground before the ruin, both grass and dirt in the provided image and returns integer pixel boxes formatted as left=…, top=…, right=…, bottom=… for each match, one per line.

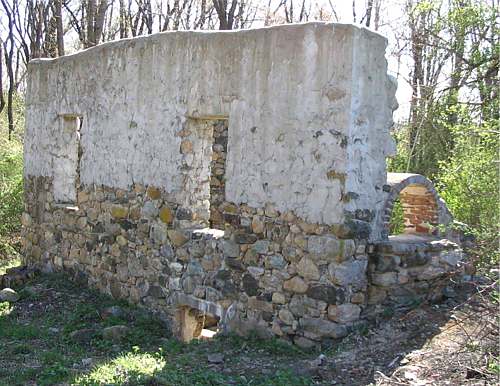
left=0, top=276, right=499, bottom=386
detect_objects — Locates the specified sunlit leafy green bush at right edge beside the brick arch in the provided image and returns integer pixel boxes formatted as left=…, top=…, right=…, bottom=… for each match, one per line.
left=438, top=121, right=500, bottom=265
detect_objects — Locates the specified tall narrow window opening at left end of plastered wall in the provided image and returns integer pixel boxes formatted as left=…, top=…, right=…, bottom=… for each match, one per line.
left=53, top=114, right=83, bottom=205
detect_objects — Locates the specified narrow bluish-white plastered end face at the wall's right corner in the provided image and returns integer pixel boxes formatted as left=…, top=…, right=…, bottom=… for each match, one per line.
left=345, top=29, right=397, bottom=239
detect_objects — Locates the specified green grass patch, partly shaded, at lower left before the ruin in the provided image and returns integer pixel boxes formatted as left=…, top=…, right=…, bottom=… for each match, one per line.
left=0, top=275, right=317, bottom=386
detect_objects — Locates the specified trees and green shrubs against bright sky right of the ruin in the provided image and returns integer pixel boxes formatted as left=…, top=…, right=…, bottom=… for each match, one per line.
left=388, top=0, right=500, bottom=265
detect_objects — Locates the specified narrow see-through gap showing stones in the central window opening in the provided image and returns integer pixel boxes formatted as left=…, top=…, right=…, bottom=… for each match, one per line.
left=210, top=119, right=228, bottom=229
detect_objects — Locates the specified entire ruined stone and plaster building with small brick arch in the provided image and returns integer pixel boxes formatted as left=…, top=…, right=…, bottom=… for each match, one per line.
left=22, top=23, right=463, bottom=347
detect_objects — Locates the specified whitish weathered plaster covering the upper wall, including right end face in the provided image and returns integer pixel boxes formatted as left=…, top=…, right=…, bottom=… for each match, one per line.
left=25, top=23, right=393, bottom=228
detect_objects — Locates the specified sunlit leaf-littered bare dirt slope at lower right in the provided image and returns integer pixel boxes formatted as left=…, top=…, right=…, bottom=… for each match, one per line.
left=312, top=283, right=500, bottom=386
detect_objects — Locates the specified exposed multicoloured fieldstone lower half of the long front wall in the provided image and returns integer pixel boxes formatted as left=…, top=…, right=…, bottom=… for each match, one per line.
left=22, top=177, right=376, bottom=346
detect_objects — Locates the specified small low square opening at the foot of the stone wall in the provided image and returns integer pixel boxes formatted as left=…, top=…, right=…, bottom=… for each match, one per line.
left=176, top=306, right=220, bottom=342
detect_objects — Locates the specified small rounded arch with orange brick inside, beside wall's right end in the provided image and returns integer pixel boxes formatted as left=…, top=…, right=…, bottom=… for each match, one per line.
left=382, top=173, right=452, bottom=237
